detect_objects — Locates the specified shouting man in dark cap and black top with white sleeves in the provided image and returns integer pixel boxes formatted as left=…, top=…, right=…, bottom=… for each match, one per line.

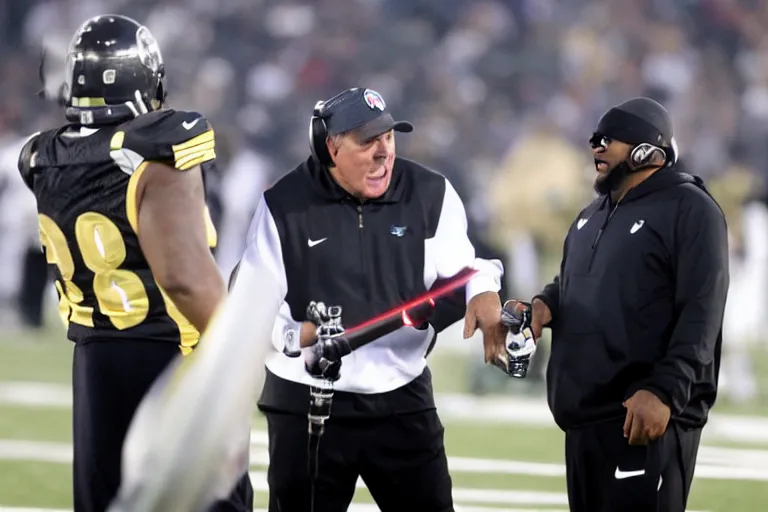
left=233, top=88, right=505, bottom=512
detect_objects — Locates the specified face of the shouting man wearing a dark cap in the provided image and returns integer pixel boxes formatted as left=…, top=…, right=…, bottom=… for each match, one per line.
left=328, top=130, right=395, bottom=199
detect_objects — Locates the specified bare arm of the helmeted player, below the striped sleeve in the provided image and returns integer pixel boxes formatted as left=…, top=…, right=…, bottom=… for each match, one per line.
left=136, top=162, right=226, bottom=333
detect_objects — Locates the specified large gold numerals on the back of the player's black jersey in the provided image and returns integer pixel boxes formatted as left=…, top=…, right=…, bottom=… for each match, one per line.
left=39, top=212, right=149, bottom=330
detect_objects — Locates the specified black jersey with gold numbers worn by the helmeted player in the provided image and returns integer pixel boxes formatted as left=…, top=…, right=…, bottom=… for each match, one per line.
left=19, top=110, right=216, bottom=352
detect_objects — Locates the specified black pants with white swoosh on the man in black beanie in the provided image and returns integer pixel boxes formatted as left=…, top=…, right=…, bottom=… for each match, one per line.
left=565, top=420, right=701, bottom=512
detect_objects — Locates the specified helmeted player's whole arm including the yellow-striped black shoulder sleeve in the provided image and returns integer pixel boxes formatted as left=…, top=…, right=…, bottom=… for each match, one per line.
left=116, top=109, right=225, bottom=333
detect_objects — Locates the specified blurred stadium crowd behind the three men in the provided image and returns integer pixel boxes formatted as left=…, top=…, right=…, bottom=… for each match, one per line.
left=0, top=0, right=768, bottom=404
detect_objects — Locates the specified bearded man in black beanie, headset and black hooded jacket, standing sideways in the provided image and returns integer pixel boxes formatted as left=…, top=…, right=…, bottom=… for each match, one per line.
left=520, top=98, right=729, bottom=512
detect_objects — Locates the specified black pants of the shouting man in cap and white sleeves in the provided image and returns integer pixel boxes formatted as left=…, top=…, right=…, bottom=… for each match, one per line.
left=265, top=410, right=453, bottom=512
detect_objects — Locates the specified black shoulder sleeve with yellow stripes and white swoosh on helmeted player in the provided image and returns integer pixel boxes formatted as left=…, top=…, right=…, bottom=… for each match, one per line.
left=110, top=109, right=216, bottom=171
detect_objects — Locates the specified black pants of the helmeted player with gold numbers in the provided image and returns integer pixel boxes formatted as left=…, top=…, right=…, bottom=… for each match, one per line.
left=72, top=340, right=253, bottom=512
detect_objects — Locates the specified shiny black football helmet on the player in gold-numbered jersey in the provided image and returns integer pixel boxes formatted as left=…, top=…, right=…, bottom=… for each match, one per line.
left=62, top=14, right=165, bottom=125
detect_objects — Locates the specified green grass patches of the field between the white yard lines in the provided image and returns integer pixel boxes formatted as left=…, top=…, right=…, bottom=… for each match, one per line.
left=0, top=326, right=768, bottom=512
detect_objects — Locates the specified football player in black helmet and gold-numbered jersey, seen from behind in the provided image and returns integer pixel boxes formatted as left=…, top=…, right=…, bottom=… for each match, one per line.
left=19, top=15, right=253, bottom=512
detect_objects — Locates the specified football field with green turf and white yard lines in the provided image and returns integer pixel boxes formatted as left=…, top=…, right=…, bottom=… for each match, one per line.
left=0, top=329, right=768, bottom=512
